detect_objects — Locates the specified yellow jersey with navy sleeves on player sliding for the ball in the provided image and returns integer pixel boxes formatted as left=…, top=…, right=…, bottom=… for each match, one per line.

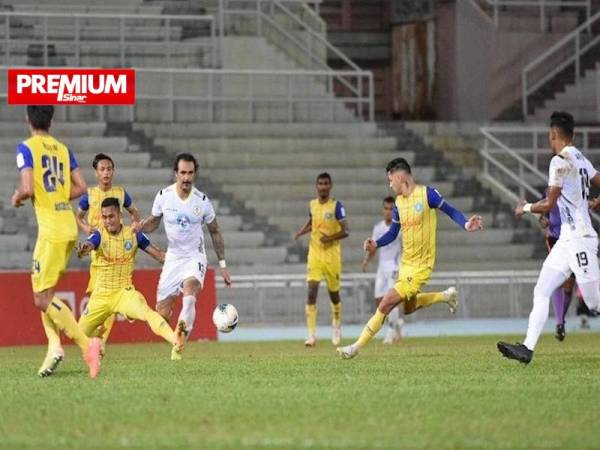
left=88, top=226, right=150, bottom=292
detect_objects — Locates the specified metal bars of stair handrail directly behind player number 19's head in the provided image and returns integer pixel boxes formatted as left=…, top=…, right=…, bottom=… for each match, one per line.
left=479, top=127, right=600, bottom=224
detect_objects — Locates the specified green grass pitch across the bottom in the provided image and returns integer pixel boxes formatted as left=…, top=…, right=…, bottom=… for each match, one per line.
left=0, top=333, right=600, bottom=449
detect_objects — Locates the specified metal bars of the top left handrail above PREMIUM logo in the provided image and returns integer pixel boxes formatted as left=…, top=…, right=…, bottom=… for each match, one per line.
left=0, top=11, right=217, bottom=67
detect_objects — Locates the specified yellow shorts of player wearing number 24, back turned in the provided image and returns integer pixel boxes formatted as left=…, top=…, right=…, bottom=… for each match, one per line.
left=31, top=239, right=75, bottom=292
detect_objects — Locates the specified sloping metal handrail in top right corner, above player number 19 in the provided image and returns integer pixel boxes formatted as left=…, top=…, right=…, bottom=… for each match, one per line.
left=521, top=12, right=600, bottom=118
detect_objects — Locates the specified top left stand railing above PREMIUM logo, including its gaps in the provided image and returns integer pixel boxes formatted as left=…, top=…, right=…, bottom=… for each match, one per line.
left=0, top=11, right=219, bottom=67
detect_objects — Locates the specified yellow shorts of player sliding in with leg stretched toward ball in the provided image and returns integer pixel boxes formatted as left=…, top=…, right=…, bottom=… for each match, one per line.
left=79, top=286, right=151, bottom=336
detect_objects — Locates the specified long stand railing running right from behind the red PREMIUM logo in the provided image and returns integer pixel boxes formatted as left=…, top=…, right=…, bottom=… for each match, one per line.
left=0, top=67, right=374, bottom=123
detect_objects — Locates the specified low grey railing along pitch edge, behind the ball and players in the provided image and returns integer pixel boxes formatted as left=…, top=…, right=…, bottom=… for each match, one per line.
left=217, top=271, right=538, bottom=324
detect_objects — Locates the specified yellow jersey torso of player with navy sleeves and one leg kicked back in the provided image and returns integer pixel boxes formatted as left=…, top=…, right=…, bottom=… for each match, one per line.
left=396, top=185, right=437, bottom=269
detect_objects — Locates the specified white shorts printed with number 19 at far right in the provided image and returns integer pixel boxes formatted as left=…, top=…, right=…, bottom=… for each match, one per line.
left=544, top=237, right=600, bottom=284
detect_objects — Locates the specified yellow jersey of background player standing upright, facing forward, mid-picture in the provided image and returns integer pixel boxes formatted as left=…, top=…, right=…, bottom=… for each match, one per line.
left=308, top=198, right=346, bottom=264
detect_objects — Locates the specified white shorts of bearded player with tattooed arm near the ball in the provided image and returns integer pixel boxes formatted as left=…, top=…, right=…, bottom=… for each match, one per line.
left=156, top=252, right=206, bottom=302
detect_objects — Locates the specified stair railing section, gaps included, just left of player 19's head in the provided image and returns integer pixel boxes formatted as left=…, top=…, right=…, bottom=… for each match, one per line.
left=479, top=126, right=600, bottom=224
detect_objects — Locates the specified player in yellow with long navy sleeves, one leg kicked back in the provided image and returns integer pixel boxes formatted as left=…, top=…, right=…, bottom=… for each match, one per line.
left=337, top=158, right=483, bottom=359
